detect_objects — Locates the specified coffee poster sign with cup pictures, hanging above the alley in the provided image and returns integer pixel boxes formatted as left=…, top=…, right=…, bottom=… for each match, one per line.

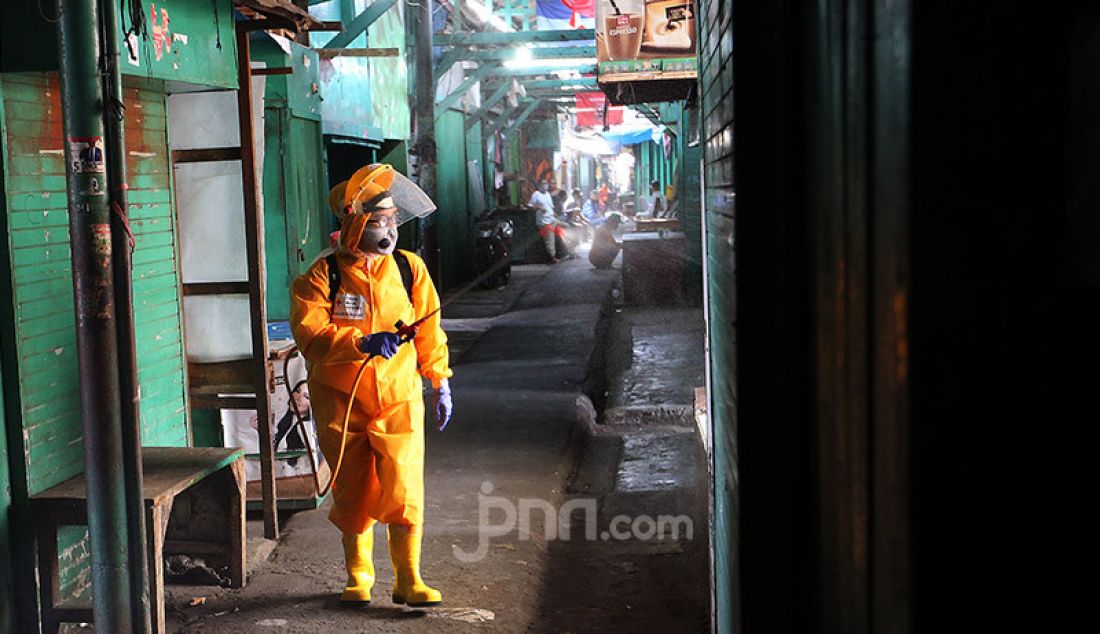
left=596, top=0, right=699, bottom=83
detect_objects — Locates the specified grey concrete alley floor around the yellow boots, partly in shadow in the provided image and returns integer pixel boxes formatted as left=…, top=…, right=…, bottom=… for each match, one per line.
left=167, top=256, right=710, bottom=633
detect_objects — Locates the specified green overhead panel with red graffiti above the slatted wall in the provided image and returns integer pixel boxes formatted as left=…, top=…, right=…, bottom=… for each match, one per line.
left=0, top=0, right=237, bottom=88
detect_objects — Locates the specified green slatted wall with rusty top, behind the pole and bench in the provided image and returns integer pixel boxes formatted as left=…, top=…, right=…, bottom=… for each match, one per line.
left=0, top=73, right=188, bottom=611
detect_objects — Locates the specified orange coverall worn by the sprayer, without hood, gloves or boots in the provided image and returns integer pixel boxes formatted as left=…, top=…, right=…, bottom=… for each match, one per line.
left=290, top=252, right=452, bottom=534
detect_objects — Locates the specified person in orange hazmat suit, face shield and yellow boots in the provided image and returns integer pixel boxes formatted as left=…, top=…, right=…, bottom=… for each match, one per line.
left=290, top=164, right=452, bottom=605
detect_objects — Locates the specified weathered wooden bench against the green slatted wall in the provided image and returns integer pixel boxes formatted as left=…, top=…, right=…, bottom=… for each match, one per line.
left=31, top=447, right=245, bottom=634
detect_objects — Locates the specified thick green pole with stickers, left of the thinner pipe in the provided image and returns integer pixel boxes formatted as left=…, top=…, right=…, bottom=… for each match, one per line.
left=57, top=0, right=133, bottom=632
